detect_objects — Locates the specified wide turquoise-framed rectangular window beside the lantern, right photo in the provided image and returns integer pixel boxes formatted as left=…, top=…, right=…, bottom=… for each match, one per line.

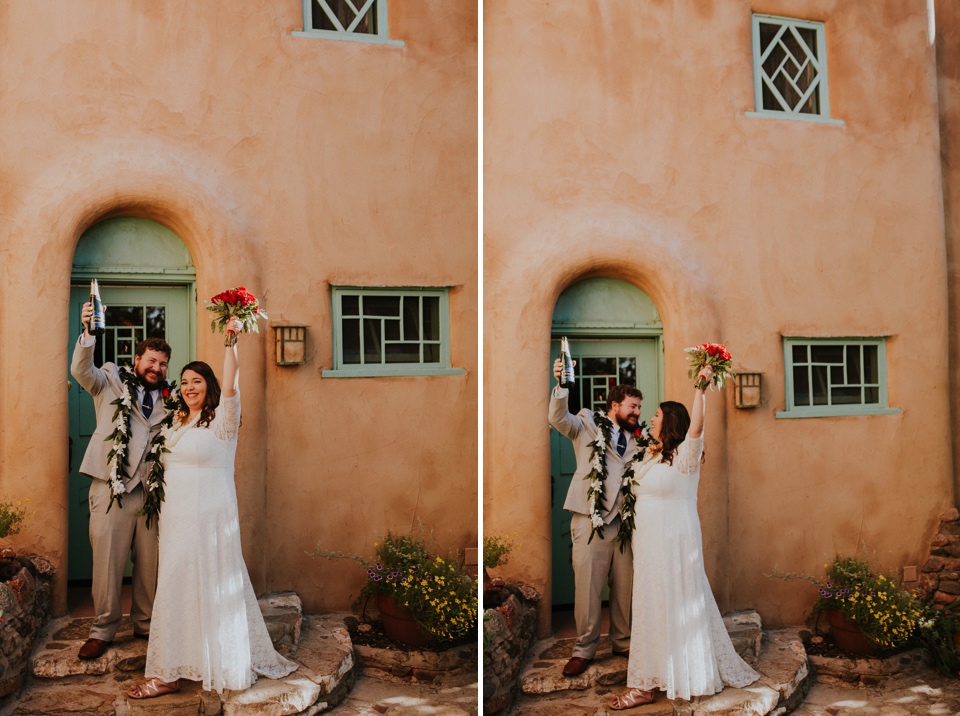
left=777, top=337, right=900, bottom=418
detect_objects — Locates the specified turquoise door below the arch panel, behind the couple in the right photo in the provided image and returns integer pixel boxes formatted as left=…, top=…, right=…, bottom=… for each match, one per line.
left=550, top=338, right=662, bottom=606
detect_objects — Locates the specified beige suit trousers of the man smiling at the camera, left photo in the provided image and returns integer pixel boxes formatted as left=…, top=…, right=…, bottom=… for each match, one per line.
left=90, top=479, right=159, bottom=641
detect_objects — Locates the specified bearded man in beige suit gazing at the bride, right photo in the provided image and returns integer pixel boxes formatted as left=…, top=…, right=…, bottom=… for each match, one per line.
left=550, top=359, right=643, bottom=676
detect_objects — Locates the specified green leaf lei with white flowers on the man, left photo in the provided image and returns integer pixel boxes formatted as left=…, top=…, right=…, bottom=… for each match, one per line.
left=104, top=366, right=179, bottom=529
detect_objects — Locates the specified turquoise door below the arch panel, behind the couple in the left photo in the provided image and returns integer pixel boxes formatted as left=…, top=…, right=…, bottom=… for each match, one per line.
left=67, top=283, right=191, bottom=581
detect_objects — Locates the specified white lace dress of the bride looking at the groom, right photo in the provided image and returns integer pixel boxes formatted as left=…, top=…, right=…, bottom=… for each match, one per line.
left=627, top=436, right=760, bottom=699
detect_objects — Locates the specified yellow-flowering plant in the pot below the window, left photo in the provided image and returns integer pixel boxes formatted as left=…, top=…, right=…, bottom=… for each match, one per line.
left=313, top=528, right=478, bottom=642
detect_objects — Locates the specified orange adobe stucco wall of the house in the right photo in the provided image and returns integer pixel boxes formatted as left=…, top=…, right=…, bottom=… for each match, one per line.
left=484, top=0, right=954, bottom=630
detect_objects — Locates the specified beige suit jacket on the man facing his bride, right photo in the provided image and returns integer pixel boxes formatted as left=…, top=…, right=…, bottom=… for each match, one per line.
left=550, top=388, right=637, bottom=524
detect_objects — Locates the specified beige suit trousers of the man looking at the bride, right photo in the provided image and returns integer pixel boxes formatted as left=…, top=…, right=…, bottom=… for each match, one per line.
left=570, top=512, right=633, bottom=659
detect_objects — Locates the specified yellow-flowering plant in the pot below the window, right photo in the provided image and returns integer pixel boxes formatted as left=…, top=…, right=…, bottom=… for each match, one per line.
left=775, top=554, right=924, bottom=649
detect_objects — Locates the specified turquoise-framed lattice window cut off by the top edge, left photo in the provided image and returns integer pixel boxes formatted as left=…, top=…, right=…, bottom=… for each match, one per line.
left=293, top=0, right=403, bottom=45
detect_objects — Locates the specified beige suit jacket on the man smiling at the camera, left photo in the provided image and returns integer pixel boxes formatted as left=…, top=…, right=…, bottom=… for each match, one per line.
left=70, top=340, right=169, bottom=492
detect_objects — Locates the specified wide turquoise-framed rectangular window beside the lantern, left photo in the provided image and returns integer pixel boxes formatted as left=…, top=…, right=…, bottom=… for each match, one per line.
left=323, top=286, right=465, bottom=377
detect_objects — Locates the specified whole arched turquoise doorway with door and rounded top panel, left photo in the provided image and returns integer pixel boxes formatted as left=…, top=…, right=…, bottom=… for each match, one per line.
left=67, top=218, right=196, bottom=586
